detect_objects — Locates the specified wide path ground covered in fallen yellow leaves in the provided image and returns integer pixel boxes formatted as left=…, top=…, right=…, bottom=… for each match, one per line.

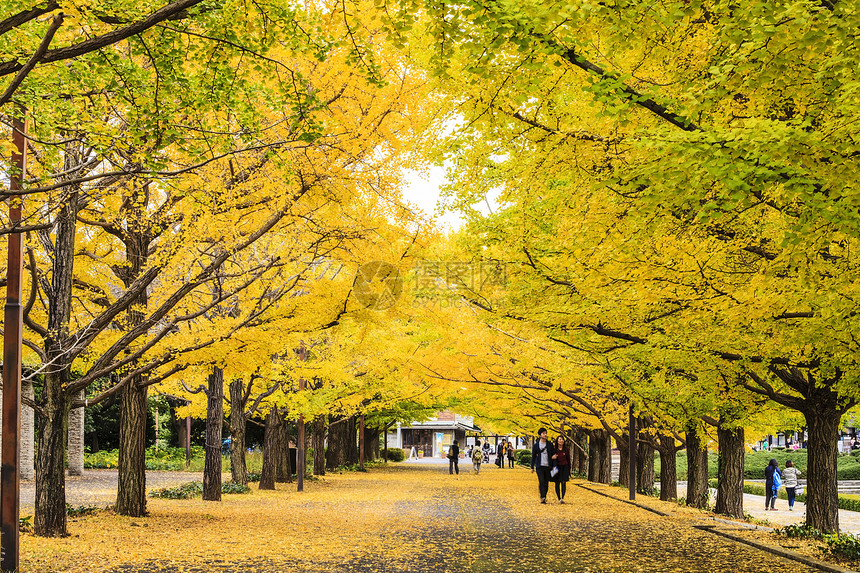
left=22, top=464, right=811, bottom=573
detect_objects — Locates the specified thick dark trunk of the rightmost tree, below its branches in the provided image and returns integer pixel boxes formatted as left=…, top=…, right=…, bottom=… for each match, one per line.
left=803, top=402, right=840, bottom=533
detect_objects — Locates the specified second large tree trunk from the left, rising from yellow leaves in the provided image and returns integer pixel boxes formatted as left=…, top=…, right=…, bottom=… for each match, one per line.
left=116, top=376, right=147, bottom=517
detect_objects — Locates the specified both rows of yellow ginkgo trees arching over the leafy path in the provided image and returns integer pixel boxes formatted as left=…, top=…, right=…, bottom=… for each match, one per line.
left=0, top=0, right=860, bottom=535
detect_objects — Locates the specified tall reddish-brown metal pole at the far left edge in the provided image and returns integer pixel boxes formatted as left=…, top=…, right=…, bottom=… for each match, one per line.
left=0, top=110, right=27, bottom=572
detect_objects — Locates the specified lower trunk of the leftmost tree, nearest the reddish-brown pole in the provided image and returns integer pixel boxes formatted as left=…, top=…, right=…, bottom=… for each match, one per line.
left=33, top=378, right=70, bottom=537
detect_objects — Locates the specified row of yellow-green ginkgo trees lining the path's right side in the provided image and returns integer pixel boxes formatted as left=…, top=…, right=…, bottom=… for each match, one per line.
left=392, top=0, right=860, bottom=531
